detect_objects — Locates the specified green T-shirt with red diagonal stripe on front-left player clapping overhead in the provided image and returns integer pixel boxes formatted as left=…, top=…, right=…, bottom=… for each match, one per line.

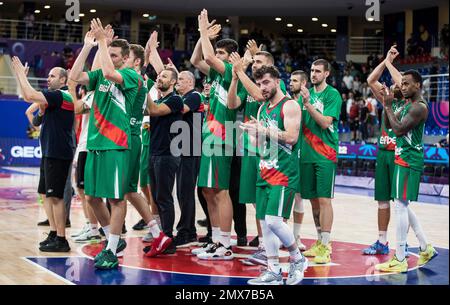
left=87, top=68, right=139, bottom=150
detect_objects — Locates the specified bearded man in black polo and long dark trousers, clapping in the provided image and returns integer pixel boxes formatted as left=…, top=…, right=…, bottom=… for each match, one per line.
left=147, top=68, right=183, bottom=253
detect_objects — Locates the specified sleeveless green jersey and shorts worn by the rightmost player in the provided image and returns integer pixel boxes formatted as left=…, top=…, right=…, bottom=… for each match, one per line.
left=391, top=100, right=428, bottom=201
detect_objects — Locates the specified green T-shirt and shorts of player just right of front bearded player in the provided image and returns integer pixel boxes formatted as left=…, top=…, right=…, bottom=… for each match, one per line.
left=300, top=85, right=342, bottom=199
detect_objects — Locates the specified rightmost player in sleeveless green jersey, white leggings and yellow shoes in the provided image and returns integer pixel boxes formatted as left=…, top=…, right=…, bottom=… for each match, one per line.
left=375, top=70, right=438, bottom=272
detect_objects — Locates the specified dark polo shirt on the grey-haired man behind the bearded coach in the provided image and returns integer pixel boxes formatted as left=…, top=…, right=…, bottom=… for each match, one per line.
left=182, top=90, right=204, bottom=156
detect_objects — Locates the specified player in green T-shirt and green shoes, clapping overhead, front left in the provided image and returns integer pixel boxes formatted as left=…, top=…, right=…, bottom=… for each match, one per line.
left=70, top=19, right=139, bottom=269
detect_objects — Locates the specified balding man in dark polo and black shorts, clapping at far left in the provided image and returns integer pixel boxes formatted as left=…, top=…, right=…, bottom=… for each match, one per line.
left=12, top=57, right=74, bottom=252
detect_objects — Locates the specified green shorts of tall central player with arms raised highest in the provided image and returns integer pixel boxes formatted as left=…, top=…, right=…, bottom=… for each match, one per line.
left=197, top=150, right=233, bottom=190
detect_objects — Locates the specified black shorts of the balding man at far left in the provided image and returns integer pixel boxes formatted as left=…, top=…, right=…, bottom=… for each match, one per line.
left=38, top=157, right=72, bottom=199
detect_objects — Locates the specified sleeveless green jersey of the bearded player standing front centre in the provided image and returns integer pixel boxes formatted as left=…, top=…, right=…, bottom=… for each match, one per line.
left=256, top=97, right=300, bottom=190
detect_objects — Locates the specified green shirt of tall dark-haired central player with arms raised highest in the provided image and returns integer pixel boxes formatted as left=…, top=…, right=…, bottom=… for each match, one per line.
left=202, top=62, right=239, bottom=146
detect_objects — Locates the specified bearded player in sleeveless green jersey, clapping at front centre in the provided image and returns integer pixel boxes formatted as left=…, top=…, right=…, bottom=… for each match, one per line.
left=242, top=66, right=308, bottom=285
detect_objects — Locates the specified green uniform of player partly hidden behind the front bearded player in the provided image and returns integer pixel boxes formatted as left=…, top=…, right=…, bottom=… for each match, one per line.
left=238, top=80, right=286, bottom=203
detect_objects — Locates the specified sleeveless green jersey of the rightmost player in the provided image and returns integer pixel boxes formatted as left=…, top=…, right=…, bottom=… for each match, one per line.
left=395, top=100, right=428, bottom=171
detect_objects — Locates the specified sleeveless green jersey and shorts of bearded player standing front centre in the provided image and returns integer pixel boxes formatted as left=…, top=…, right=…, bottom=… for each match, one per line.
left=256, top=97, right=300, bottom=219
